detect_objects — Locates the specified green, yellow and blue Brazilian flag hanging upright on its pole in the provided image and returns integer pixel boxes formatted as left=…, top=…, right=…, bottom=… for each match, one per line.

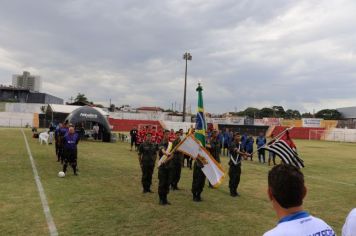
left=194, top=83, right=206, bottom=147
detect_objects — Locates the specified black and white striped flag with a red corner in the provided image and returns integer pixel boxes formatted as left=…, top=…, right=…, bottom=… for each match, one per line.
left=263, top=130, right=304, bottom=168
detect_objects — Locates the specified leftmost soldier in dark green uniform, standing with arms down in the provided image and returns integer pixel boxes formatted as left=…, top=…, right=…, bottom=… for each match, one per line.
left=138, top=133, right=157, bottom=193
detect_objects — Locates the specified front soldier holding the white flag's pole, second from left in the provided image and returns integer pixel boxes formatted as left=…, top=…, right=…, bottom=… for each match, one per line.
left=158, top=130, right=171, bottom=205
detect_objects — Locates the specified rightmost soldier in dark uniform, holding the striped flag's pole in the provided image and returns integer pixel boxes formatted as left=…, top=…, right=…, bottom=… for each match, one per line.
left=229, top=133, right=250, bottom=197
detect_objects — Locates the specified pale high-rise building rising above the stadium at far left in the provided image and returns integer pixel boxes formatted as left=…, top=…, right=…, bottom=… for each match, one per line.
left=12, top=71, right=42, bottom=92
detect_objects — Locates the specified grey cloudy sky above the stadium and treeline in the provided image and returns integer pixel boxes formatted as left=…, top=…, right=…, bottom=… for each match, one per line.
left=0, top=0, right=356, bottom=113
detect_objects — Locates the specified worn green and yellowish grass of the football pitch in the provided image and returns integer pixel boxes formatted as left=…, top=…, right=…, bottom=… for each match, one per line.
left=0, top=128, right=356, bottom=235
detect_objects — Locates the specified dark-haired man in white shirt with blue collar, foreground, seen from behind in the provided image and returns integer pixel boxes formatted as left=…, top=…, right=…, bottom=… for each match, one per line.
left=264, top=164, right=335, bottom=236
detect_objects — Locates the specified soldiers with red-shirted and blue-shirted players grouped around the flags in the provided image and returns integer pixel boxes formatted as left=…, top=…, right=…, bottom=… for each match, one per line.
left=130, top=127, right=275, bottom=205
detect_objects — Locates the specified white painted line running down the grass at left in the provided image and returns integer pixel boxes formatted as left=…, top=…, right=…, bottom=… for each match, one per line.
left=21, top=129, right=58, bottom=236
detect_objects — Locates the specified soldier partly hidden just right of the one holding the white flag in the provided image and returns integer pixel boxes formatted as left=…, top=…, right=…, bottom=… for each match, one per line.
left=169, top=131, right=183, bottom=190
